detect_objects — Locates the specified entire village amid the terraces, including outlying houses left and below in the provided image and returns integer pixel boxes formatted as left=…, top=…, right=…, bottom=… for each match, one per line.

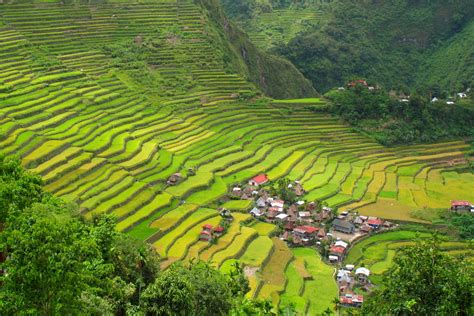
left=193, top=174, right=397, bottom=307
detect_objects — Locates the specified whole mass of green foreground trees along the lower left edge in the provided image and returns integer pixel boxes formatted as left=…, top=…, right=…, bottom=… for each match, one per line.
left=0, top=156, right=272, bottom=315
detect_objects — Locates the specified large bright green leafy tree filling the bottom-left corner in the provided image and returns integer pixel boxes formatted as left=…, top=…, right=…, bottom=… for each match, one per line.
left=0, top=204, right=104, bottom=315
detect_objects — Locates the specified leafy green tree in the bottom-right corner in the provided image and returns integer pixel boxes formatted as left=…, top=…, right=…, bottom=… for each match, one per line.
left=363, top=237, right=474, bottom=315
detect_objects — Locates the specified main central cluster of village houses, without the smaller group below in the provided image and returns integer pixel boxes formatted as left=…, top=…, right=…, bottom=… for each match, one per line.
left=231, top=174, right=393, bottom=263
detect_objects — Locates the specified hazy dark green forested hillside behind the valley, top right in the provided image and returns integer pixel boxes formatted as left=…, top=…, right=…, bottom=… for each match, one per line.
left=223, top=0, right=474, bottom=92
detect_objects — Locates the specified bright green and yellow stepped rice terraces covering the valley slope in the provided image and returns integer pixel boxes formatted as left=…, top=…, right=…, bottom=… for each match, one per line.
left=0, top=0, right=474, bottom=315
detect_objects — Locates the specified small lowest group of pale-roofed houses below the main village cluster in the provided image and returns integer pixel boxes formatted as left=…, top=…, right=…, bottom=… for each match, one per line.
left=336, top=265, right=372, bottom=307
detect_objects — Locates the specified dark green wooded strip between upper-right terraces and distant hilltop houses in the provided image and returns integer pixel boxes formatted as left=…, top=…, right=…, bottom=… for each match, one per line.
left=326, top=85, right=474, bottom=145
